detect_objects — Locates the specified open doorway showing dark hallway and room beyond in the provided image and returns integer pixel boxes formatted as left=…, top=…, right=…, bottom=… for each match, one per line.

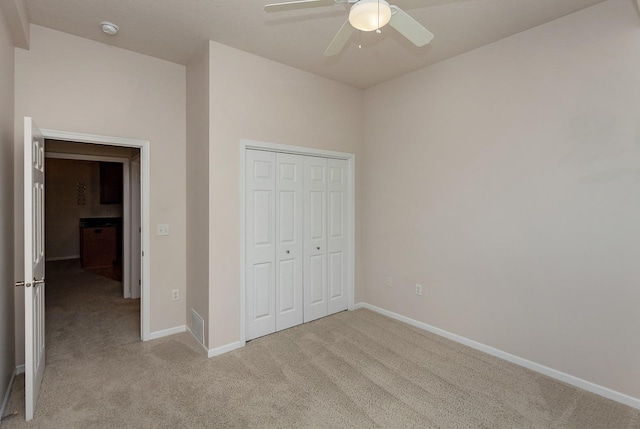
left=45, top=140, right=141, bottom=356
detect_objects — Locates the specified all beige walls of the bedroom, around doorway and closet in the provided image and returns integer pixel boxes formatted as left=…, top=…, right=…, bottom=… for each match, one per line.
left=6, top=0, right=640, bottom=404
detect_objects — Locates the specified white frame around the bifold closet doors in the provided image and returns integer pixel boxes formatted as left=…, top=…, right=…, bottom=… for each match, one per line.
left=240, top=139, right=356, bottom=346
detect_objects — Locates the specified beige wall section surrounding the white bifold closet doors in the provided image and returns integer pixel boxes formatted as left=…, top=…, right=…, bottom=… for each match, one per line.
left=209, top=42, right=362, bottom=348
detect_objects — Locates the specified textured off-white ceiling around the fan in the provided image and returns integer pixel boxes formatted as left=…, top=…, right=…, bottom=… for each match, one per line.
left=25, top=0, right=603, bottom=88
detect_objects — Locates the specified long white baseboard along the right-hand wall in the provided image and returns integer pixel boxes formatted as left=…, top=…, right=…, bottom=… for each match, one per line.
left=353, top=302, right=640, bottom=410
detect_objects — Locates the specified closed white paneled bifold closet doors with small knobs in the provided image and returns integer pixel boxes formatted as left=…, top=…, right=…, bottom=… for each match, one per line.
left=245, top=150, right=348, bottom=340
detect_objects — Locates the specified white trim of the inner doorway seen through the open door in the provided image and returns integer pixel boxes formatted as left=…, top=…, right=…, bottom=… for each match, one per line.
left=44, top=152, right=131, bottom=298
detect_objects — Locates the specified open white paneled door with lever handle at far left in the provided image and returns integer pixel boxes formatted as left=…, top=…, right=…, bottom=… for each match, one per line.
left=24, top=117, right=45, bottom=420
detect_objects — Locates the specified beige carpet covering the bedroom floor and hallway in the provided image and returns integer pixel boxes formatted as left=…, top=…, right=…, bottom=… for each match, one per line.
left=1, top=264, right=640, bottom=429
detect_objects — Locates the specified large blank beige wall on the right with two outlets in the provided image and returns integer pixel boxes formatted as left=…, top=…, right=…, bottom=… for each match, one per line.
left=361, top=0, right=640, bottom=398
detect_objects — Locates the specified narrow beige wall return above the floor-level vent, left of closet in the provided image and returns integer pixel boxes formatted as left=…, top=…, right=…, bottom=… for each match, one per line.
left=186, top=43, right=209, bottom=346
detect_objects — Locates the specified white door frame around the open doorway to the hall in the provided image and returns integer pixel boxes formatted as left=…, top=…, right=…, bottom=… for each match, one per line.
left=41, top=129, right=151, bottom=341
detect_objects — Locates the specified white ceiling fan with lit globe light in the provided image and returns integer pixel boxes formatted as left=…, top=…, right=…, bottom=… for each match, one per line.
left=264, top=0, right=434, bottom=56
